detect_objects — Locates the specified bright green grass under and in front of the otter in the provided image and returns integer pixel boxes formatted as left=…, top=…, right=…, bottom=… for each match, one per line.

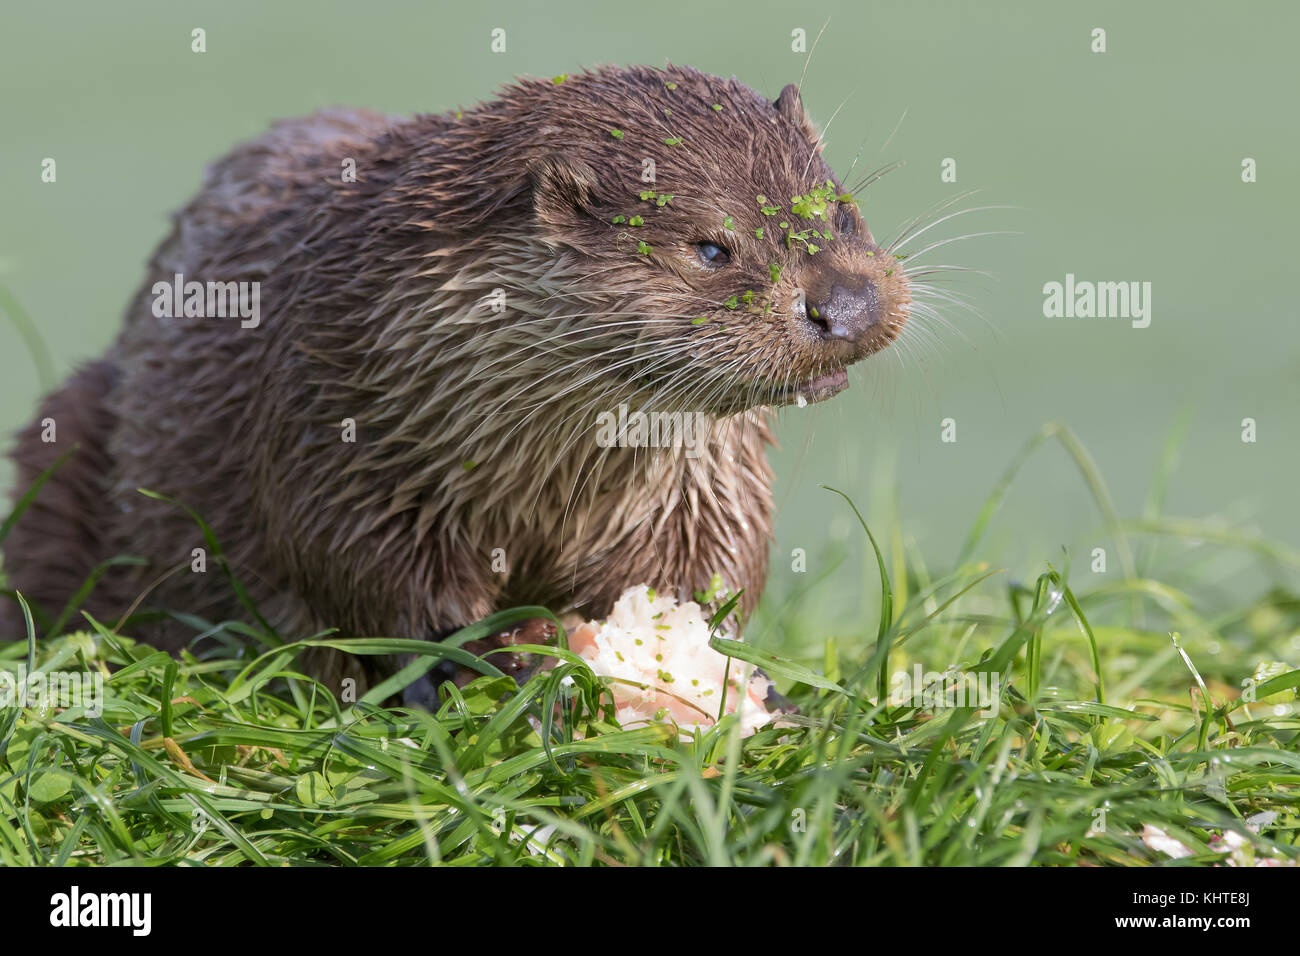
left=0, top=425, right=1300, bottom=866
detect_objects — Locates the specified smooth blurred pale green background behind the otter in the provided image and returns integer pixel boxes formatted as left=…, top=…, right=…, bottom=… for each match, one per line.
left=0, top=0, right=1300, bottom=630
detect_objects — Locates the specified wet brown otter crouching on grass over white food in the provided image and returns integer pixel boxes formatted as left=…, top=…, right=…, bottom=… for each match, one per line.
left=0, top=66, right=910, bottom=684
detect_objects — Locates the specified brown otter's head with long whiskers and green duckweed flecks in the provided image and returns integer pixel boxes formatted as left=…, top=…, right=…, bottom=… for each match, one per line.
left=529, top=68, right=910, bottom=414
